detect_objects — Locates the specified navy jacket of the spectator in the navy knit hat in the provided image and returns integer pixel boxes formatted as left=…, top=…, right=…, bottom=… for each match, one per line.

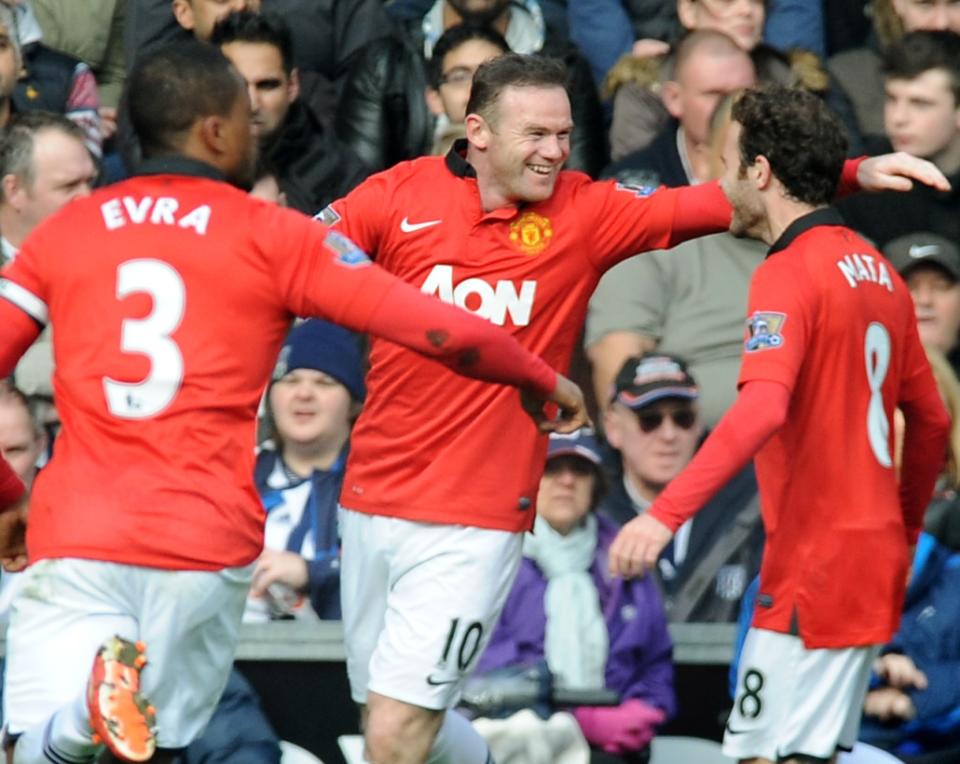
left=254, top=448, right=347, bottom=621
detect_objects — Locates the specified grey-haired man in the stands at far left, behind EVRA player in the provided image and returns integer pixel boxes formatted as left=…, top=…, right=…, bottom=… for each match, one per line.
left=0, top=112, right=97, bottom=432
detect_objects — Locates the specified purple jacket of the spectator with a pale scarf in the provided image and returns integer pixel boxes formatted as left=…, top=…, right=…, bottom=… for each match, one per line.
left=477, top=515, right=676, bottom=718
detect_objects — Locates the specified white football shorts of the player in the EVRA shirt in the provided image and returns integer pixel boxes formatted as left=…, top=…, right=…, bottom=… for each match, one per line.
left=3, top=559, right=253, bottom=748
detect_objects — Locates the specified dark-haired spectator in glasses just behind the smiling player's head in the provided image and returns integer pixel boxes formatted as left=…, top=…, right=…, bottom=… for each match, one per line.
left=425, top=24, right=510, bottom=154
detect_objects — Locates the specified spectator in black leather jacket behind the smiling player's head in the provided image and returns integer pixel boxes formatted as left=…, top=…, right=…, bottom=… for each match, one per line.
left=337, top=0, right=607, bottom=177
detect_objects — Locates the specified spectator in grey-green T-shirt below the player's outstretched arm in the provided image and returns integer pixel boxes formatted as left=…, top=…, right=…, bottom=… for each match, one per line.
left=584, top=95, right=767, bottom=427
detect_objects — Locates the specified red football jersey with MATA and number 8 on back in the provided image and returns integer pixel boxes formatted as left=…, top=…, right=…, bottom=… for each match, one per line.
left=740, top=209, right=936, bottom=648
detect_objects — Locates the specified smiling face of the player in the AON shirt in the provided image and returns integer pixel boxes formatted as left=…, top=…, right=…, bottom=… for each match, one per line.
left=467, top=86, right=573, bottom=210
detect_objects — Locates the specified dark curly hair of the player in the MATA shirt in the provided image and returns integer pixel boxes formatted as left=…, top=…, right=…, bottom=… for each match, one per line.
left=733, top=85, right=847, bottom=205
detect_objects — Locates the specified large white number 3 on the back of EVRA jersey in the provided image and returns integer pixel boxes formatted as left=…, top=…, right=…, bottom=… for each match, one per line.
left=103, top=260, right=187, bottom=419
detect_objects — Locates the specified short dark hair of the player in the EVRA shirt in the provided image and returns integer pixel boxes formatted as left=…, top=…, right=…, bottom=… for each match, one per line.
left=125, top=40, right=245, bottom=157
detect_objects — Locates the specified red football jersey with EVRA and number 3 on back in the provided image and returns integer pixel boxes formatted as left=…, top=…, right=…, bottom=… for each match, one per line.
left=0, top=161, right=432, bottom=569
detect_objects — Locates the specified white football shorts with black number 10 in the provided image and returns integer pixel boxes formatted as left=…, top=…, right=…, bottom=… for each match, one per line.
left=340, top=507, right=523, bottom=710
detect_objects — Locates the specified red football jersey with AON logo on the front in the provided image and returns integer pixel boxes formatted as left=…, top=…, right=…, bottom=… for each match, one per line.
left=326, top=152, right=730, bottom=531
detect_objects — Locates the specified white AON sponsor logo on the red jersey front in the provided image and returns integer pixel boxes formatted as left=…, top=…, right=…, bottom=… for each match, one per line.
left=420, top=265, right=537, bottom=326
